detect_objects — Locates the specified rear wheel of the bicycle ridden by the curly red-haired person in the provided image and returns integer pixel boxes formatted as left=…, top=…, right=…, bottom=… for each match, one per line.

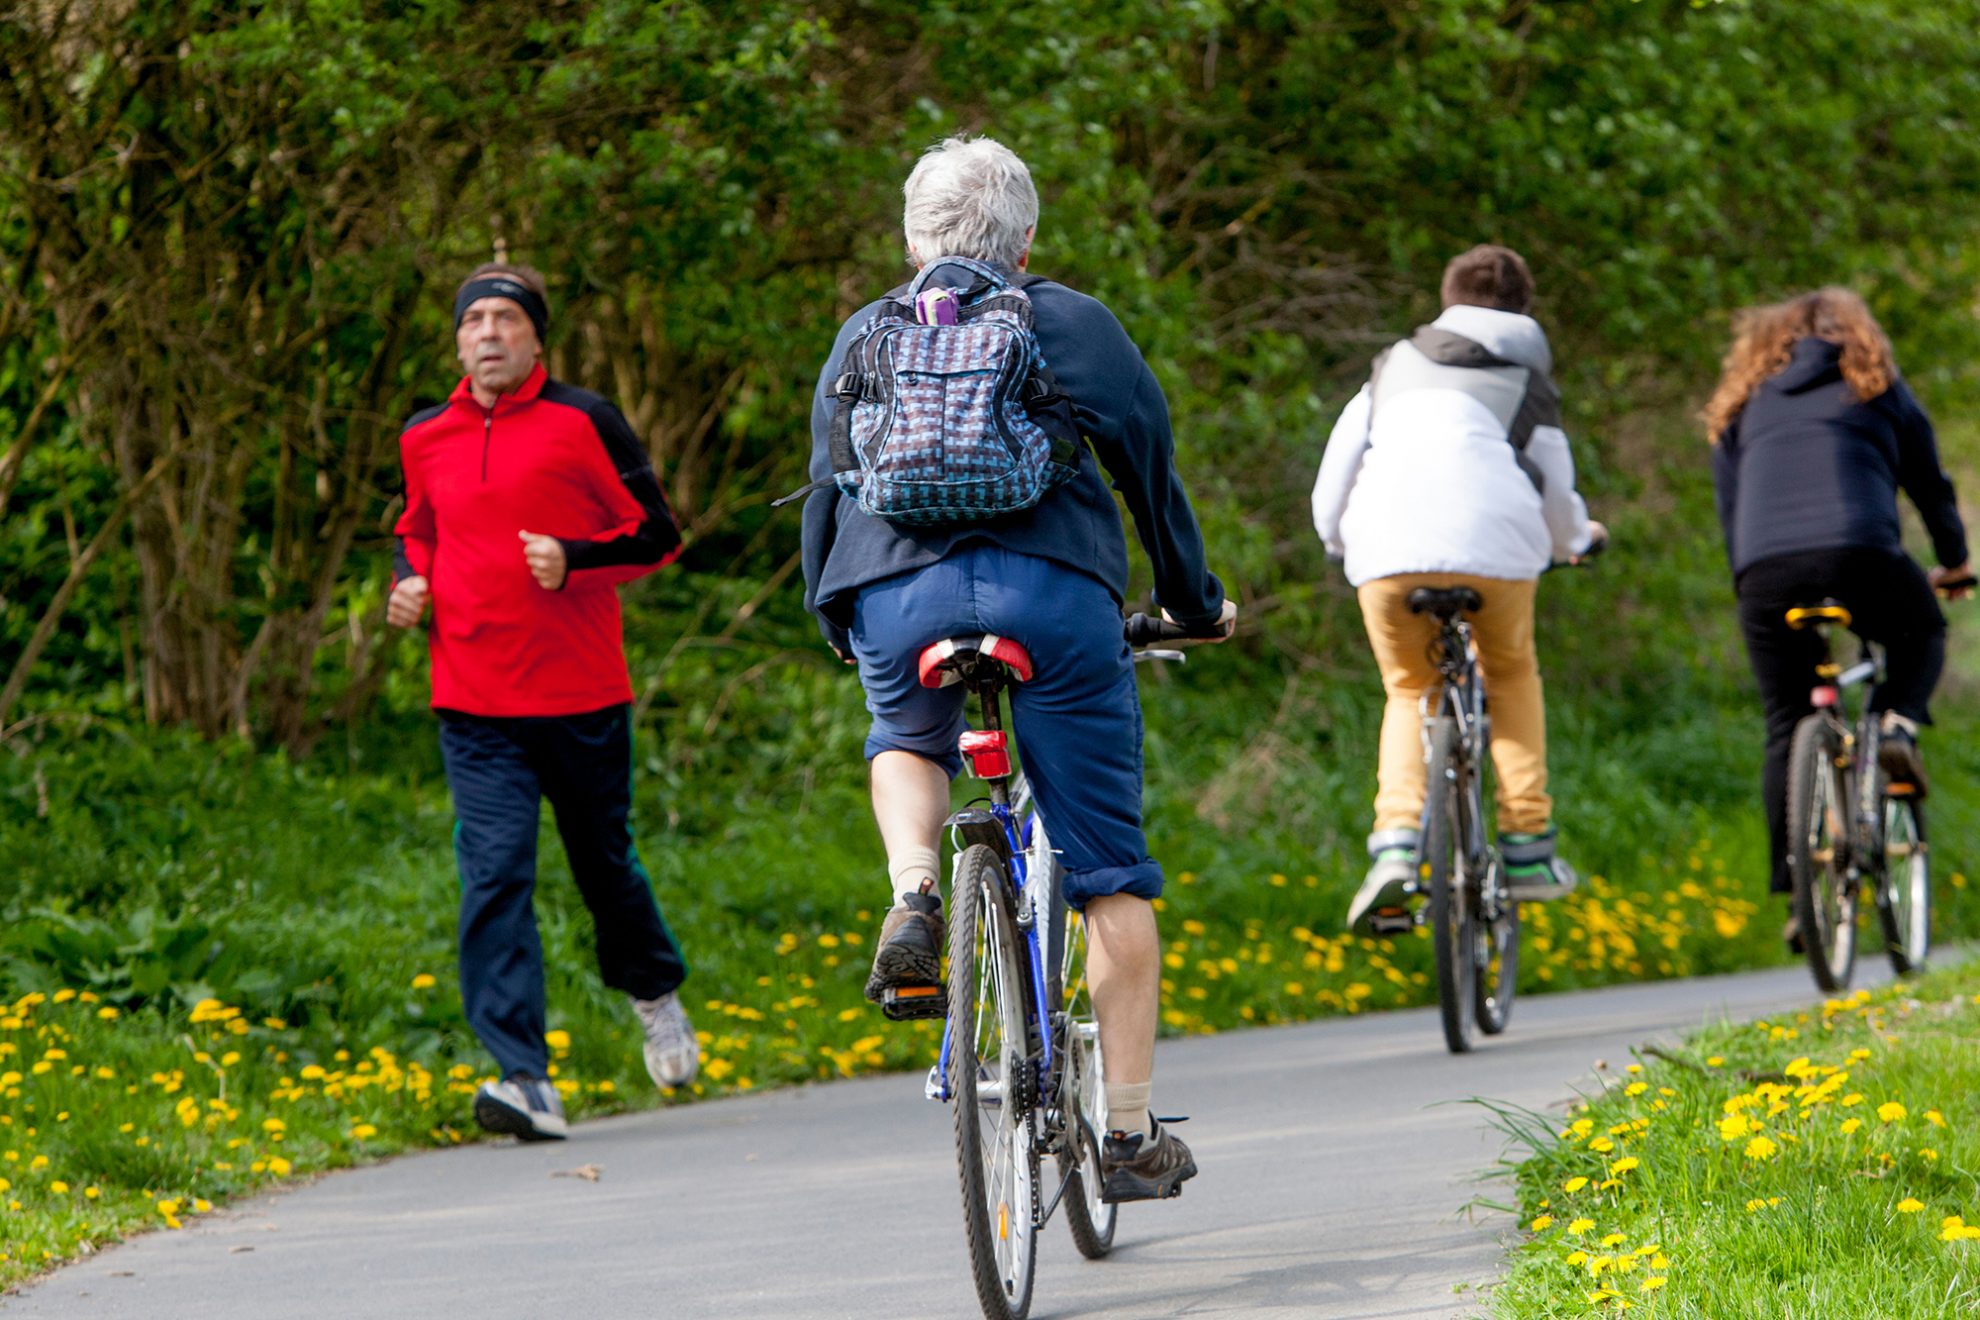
left=1788, top=714, right=1857, bottom=993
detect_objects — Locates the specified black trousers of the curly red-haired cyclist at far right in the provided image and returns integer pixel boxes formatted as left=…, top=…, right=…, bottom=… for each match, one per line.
left=1734, top=548, right=1946, bottom=895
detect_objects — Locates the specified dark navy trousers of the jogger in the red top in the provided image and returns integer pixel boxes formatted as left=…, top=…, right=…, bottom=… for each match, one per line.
left=440, top=707, right=687, bottom=1077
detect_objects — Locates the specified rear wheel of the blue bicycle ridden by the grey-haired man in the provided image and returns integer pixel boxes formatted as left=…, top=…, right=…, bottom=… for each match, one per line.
left=946, top=843, right=1038, bottom=1320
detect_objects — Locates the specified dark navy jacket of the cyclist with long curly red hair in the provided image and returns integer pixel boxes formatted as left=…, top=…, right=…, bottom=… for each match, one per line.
left=1713, top=338, right=1966, bottom=578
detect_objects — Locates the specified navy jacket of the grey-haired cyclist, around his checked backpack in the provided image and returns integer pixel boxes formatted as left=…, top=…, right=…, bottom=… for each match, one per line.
left=804, top=267, right=1224, bottom=651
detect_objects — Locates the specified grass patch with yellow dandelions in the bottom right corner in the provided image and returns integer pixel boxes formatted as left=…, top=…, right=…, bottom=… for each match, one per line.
left=1493, top=962, right=1980, bottom=1320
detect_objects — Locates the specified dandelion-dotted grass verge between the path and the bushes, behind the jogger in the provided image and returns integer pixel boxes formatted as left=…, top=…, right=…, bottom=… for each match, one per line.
left=0, top=439, right=1980, bottom=1284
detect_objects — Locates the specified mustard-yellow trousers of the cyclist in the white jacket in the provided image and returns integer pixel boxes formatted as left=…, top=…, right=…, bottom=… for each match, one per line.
left=1360, top=574, right=1554, bottom=833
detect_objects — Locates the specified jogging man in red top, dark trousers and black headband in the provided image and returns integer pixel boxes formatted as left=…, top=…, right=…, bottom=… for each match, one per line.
left=386, top=265, right=699, bottom=1140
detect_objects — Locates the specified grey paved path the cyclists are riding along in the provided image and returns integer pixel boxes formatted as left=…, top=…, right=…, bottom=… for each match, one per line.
left=0, top=958, right=1879, bottom=1320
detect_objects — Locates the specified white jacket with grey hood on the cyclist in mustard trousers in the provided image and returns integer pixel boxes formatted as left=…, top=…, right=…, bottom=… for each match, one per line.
left=1313, top=307, right=1592, bottom=586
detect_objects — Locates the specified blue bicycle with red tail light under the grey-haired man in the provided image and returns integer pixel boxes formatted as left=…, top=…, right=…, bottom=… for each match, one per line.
left=881, top=615, right=1196, bottom=1320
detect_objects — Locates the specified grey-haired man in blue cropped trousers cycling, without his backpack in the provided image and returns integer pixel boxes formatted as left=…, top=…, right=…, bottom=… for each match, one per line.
left=804, top=139, right=1236, bottom=1201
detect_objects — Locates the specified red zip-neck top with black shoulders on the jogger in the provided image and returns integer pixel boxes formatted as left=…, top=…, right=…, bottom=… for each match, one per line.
left=394, top=362, right=681, bottom=716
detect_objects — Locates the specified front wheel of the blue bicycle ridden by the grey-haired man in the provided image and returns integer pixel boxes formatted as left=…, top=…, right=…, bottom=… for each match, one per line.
left=1034, top=858, right=1121, bottom=1261
